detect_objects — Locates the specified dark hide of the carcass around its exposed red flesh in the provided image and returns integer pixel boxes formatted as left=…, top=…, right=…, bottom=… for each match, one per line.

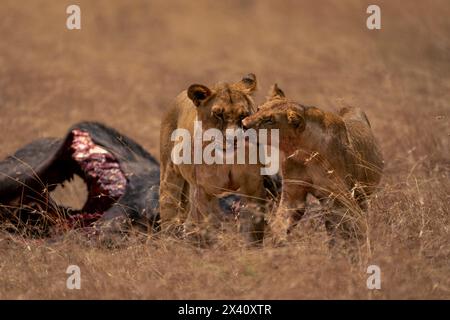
left=0, top=122, right=159, bottom=234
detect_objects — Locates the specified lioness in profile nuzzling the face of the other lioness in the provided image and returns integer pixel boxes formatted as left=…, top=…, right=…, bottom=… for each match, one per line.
left=242, top=85, right=383, bottom=241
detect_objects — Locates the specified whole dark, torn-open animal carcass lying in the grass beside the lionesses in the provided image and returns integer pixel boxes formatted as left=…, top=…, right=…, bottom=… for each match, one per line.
left=0, top=122, right=159, bottom=233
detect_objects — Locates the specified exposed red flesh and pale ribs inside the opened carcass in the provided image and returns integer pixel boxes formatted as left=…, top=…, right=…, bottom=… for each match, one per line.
left=63, top=129, right=127, bottom=227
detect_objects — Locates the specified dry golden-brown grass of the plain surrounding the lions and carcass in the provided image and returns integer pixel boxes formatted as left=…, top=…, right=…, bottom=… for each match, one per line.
left=0, top=0, right=450, bottom=299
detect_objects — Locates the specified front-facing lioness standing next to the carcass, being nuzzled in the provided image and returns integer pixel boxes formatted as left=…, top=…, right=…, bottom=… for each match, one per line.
left=160, top=74, right=266, bottom=240
